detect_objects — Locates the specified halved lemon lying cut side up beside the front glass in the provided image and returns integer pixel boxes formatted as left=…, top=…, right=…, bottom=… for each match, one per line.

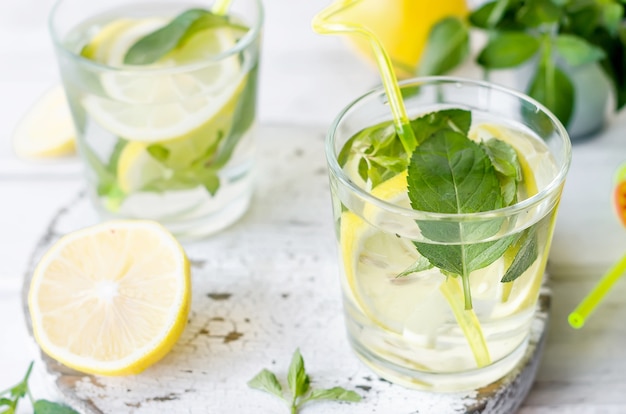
left=28, top=220, right=191, bottom=375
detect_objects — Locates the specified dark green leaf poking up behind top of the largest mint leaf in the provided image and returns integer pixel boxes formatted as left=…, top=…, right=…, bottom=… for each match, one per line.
left=410, top=109, right=472, bottom=144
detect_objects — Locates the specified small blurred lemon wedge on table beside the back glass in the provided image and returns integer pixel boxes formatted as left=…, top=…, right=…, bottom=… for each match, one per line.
left=13, top=85, right=76, bottom=159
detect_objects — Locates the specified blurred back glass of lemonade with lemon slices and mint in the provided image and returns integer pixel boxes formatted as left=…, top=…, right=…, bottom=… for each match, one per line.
left=50, top=0, right=263, bottom=238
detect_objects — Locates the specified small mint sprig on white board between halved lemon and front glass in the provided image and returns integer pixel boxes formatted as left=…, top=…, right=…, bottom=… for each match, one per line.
left=248, top=349, right=361, bottom=414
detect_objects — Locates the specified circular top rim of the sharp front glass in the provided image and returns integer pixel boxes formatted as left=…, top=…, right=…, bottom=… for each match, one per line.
left=325, top=76, right=572, bottom=221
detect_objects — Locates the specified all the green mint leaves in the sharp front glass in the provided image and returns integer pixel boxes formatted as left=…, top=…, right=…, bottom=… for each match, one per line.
left=338, top=109, right=538, bottom=309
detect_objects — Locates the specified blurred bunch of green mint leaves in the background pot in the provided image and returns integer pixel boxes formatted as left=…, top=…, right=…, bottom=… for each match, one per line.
left=417, top=0, right=626, bottom=126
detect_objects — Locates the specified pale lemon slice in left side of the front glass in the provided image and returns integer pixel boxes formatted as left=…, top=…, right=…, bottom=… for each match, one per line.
left=340, top=173, right=445, bottom=334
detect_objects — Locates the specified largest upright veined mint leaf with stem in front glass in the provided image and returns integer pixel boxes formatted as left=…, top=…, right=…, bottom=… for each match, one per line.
left=407, top=129, right=511, bottom=309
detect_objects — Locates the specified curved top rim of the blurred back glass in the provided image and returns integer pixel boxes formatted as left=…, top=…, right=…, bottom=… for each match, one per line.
left=48, top=0, right=265, bottom=73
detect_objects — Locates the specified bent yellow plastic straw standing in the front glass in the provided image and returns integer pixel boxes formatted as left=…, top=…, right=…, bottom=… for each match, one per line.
left=312, top=0, right=417, bottom=154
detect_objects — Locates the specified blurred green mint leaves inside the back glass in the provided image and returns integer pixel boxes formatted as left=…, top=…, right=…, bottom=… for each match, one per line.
left=81, top=8, right=258, bottom=210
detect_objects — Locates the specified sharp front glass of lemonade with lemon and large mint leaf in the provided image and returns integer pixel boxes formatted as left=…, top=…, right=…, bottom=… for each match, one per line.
left=326, top=77, right=571, bottom=391
